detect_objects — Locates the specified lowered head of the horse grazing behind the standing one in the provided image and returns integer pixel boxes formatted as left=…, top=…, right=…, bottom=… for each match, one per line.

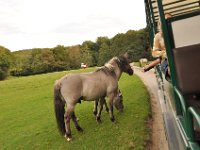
left=114, top=90, right=124, bottom=112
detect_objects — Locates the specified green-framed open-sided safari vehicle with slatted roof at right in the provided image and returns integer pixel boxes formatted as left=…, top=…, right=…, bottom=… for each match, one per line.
left=144, top=0, right=200, bottom=150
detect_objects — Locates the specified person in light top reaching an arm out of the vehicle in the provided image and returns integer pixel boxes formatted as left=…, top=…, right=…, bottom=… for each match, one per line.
left=143, top=13, right=172, bottom=80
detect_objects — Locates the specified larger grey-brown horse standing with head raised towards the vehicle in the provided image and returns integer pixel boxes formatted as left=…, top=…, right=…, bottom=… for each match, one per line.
left=54, top=53, right=133, bottom=141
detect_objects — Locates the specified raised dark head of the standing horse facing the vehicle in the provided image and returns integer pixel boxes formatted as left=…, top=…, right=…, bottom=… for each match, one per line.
left=118, top=53, right=133, bottom=75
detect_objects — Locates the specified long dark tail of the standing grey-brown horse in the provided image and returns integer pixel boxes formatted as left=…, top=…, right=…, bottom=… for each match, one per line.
left=54, top=81, right=66, bottom=135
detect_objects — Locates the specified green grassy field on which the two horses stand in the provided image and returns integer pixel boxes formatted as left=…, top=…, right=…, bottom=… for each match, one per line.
left=0, top=68, right=150, bottom=150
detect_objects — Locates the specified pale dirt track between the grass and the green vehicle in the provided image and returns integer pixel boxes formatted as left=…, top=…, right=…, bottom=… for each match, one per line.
left=133, top=67, right=168, bottom=150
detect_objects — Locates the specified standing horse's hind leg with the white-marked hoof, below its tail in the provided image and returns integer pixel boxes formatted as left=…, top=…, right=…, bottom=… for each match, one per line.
left=64, top=105, right=74, bottom=141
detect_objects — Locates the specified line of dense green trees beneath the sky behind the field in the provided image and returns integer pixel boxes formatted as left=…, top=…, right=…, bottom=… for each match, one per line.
left=0, top=29, right=151, bottom=80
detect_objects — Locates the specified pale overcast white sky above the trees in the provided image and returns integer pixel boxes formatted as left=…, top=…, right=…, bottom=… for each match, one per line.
left=0, top=0, right=146, bottom=51
